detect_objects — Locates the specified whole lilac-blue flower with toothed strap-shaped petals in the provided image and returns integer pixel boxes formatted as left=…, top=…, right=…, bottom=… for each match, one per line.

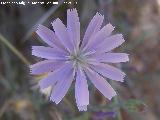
left=31, top=9, right=129, bottom=111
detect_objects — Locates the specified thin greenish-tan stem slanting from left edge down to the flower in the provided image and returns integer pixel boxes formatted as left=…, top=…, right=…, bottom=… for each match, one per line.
left=0, top=34, right=30, bottom=65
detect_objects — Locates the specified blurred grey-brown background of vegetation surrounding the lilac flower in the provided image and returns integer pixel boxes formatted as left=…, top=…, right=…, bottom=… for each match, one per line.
left=0, top=0, right=160, bottom=120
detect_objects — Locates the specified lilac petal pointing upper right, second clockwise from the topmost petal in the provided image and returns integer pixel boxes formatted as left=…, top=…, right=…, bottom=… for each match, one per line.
left=84, top=24, right=114, bottom=51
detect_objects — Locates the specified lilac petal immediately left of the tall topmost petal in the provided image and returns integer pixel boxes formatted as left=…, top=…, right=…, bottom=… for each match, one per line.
left=52, top=19, right=73, bottom=51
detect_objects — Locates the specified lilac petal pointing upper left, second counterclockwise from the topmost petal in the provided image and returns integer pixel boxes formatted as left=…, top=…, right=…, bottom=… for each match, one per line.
left=36, top=25, right=66, bottom=49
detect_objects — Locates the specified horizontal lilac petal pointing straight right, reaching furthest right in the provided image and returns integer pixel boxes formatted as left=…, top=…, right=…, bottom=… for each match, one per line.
left=92, top=53, right=129, bottom=63
